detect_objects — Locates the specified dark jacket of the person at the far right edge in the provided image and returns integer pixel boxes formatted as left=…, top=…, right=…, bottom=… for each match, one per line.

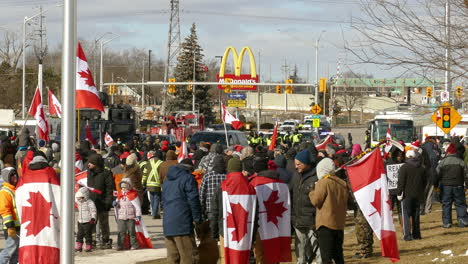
left=436, top=154, right=468, bottom=187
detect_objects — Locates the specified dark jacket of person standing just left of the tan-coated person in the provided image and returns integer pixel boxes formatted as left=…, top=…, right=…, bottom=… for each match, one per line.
left=289, top=168, right=318, bottom=229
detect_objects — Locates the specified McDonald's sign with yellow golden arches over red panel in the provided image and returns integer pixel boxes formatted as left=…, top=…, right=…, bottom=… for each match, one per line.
left=217, top=47, right=258, bottom=91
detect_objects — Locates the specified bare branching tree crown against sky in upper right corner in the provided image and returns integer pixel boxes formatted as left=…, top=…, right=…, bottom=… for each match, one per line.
left=346, top=0, right=468, bottom=80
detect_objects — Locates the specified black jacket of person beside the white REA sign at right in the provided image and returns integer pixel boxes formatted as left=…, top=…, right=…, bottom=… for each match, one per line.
left=397, top=158, right=427, bottom=200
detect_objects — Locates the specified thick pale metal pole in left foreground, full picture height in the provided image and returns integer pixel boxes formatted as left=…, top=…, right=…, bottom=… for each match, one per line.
left=60, top=0, right=77, bottom=264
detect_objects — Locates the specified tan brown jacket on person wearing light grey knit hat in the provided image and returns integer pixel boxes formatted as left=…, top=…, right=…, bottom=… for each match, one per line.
left=309, top=176, right=348, bottom=230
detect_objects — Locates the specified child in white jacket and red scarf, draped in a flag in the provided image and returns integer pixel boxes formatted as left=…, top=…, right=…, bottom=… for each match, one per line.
left=114, top=178, right=141, bottom=250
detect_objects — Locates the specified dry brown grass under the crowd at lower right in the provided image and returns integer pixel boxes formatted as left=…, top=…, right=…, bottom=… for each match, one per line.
left=140, top=204, right=468, bottom=264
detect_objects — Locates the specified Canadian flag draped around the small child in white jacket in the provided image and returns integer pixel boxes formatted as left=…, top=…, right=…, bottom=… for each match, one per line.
left=114, top=187, right=153, bottom=249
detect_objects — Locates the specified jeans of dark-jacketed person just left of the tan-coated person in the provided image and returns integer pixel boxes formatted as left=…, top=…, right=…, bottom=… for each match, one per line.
left=294, top=228, right=322, bottom=264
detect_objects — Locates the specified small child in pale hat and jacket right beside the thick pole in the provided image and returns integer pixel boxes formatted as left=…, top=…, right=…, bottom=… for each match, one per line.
left=75, top=187, right=96, bottom=252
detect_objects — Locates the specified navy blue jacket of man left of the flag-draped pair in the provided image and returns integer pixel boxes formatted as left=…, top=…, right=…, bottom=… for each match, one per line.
left=162, top=164, right=201, bottom=236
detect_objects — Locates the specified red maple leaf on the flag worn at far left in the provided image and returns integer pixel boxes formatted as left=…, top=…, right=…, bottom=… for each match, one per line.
left=22, top=192, right=52, bottom=236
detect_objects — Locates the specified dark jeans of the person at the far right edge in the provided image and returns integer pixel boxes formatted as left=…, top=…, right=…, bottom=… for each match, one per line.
left=441, top=185, right=468, bottom=225
